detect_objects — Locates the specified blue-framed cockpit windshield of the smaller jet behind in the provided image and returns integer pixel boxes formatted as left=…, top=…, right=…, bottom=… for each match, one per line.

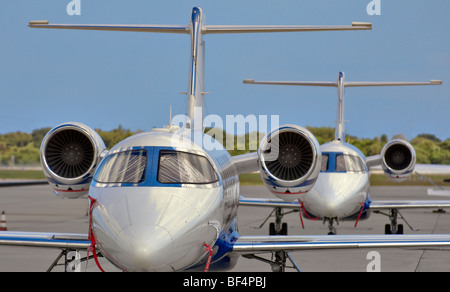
left=320, top=152, right=367, bottom=172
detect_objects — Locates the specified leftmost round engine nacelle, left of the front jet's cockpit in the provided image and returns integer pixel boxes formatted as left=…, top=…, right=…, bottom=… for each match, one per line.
left=41, top=123, right=106, bottom=198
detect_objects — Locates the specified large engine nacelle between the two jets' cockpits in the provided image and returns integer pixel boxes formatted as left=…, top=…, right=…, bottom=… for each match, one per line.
left=258, top=125, right=322, bottom=201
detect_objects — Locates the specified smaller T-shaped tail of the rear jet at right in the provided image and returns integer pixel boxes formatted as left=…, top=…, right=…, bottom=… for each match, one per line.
left=244, top=72, right=442, bottom=142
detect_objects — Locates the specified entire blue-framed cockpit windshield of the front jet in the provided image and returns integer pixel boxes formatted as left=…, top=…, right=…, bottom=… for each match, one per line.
left=94, top=147, right=219, bottom=187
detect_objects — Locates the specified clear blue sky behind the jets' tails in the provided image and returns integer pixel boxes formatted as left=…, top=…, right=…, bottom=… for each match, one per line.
left=0, top=0, right=450, bottom=139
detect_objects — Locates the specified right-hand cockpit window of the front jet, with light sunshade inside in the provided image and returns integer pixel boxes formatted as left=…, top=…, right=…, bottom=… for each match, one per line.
left=158, top=150, right=219, bottom=184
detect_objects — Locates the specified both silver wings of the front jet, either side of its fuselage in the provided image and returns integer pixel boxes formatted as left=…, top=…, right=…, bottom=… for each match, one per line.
left=0, top=231, right=450, bottom=254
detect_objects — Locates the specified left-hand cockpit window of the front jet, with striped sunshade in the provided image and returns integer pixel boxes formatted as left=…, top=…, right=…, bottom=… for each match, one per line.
left=94, top=149, right=147, bottom=184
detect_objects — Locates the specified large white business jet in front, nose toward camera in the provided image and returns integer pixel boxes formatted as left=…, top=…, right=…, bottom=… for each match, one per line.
left=0, top=7, right=450, bottom=271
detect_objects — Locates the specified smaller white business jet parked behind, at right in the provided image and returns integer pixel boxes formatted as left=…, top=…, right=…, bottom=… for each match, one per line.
left=240, top=72, right=450, bottom=235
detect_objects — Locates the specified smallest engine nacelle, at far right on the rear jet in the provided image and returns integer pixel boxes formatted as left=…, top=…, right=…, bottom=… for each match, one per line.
left=381, top=139, right=416, bottom=182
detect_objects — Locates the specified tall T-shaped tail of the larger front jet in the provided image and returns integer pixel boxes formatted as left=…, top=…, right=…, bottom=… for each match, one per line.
left=29, top=7, right=372, bottom=130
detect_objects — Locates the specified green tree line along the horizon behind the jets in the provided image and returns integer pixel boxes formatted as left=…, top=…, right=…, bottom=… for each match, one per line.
left=0, top=125, right=450, bottom=165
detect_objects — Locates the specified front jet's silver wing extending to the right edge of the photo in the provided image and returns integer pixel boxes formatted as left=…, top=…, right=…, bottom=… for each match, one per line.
left=232, top=234, right=450, bottom=254
